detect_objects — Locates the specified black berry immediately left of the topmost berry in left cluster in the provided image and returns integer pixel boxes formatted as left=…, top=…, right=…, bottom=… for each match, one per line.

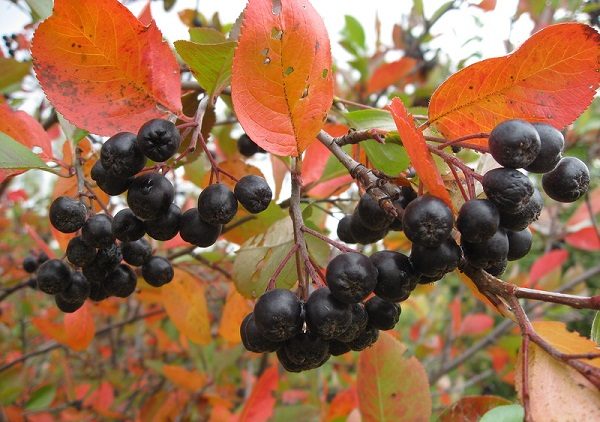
left=100, top=132, right=146, bottom=179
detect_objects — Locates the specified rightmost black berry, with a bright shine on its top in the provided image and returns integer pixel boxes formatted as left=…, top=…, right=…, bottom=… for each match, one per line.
left=542, top=157, right=590, bottom=202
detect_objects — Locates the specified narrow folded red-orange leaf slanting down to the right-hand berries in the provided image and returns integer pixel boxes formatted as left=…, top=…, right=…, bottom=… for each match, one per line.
left=387, top=98, right=452, bottom=207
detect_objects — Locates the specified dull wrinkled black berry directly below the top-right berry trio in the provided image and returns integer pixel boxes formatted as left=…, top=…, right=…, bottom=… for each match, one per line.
left=481, top=168, right=533, bottom=213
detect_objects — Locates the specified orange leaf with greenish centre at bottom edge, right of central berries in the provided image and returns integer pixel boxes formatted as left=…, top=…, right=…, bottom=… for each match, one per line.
left=356, top=332, right=431, bottom=421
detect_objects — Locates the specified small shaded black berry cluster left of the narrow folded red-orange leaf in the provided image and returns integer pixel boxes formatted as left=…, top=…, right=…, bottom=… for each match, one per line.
left=337, top=186, right=417, bottom=244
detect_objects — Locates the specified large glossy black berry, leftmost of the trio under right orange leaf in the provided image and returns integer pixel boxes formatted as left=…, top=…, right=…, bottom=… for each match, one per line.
left=488, top=120, right=541, bottom=168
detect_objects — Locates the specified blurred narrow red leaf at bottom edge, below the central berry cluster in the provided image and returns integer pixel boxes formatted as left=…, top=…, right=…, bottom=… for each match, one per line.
left=239, top=366, right=279, bottom=422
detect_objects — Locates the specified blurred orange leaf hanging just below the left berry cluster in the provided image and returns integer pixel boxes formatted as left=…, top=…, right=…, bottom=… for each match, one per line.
left=160, top=268, right=210, bottom=344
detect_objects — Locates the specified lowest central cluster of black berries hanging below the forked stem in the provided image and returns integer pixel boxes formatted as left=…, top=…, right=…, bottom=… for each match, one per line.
left=240, top=251, right=418, bottom=372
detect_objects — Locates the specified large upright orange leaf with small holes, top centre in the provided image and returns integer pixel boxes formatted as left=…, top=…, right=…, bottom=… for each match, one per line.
left=231, top=0, right=333, bottom=156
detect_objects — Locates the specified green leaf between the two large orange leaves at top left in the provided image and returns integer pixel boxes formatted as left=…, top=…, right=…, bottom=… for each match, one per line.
left=175, top=34, right=236, bottom=95
